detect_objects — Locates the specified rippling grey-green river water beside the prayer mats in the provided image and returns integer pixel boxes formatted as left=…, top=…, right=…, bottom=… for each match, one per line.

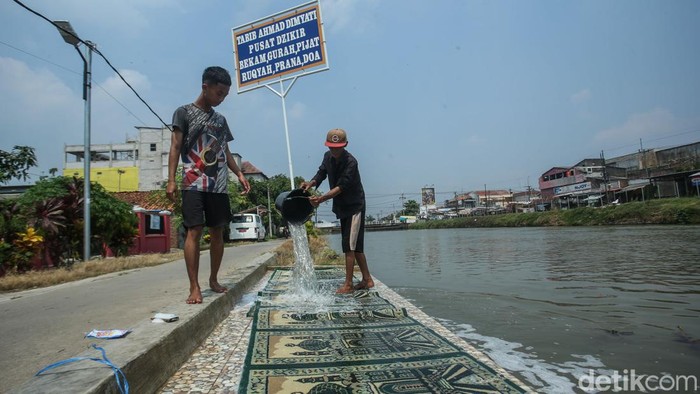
left=328, top=226, right=700, bottom=393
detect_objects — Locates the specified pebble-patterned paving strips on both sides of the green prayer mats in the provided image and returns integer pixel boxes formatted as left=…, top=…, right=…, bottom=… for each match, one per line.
left=159, top=272, right=527, bottom=394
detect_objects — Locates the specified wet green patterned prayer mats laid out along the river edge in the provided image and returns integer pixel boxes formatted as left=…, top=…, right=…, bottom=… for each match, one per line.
left=239, top=269, right=525, bottom=394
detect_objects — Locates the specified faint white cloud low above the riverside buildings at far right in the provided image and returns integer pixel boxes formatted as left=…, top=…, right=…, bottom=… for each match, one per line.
left=594, top=108, right=688, bottom=145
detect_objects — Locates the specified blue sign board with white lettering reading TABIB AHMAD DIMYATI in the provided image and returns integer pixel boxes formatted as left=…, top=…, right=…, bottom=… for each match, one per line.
left=232, top=1, right=328, bottom=93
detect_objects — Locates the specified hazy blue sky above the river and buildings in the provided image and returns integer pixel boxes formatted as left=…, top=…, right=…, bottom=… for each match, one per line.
left=0, top=0, right=700, bottom=220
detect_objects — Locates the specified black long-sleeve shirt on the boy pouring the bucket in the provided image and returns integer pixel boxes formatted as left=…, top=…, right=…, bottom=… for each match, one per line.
left=311, top=150, right=365, bottom=219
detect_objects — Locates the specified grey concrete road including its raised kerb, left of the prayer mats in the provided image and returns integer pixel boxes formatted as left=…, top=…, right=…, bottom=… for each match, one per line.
left=0, top=241, right=283, bottom=393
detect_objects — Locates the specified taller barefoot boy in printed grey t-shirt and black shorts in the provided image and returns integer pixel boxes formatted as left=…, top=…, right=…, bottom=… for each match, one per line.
left=166, top=67, right=250, bottom=304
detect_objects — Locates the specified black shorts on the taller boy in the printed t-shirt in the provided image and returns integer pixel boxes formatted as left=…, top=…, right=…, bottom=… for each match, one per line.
left=182, top=190, right=231, bottom=228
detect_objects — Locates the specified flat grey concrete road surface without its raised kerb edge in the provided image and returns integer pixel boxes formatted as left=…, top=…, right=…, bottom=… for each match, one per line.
left=0, top=240, right=283, bottom=393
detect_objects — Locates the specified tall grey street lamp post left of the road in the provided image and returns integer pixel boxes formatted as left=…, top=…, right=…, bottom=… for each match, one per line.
left=54, top=21, right=95, bottom=261
